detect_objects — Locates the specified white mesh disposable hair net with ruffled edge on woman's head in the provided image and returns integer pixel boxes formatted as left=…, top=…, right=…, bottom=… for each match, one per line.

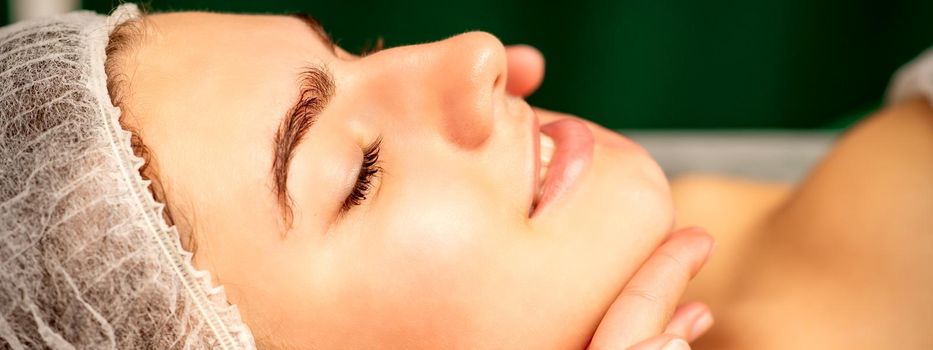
left=0, top=4, right=255, bottom=349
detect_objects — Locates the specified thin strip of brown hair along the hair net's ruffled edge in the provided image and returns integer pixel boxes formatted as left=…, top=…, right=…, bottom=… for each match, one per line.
left=104, top=9, right=197, bottom=253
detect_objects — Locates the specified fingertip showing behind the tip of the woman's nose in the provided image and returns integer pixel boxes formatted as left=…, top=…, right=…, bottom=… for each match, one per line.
left=505, top=45, right=544, bottom=97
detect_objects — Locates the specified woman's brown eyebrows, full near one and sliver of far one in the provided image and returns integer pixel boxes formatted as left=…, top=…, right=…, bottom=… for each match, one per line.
left=272, top=15, right=335, bottom=228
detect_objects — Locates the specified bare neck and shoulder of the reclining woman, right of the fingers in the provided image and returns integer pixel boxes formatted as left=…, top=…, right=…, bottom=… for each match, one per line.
left=672, top=98, right=933, bottom=350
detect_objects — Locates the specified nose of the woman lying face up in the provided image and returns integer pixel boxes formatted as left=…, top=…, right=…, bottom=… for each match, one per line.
left=368, top=32, right=507, bottom=150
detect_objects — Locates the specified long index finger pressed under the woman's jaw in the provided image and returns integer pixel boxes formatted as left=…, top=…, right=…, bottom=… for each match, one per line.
left=591, top=228, right=713, bottom=349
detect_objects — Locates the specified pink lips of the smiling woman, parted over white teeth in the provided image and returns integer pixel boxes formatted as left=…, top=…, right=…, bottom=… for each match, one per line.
left=529, top=118, right=595, bottom=217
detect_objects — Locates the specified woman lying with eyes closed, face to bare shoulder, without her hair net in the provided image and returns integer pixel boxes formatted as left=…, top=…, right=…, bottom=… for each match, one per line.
left=0, top=3, right=933, bottom=349
